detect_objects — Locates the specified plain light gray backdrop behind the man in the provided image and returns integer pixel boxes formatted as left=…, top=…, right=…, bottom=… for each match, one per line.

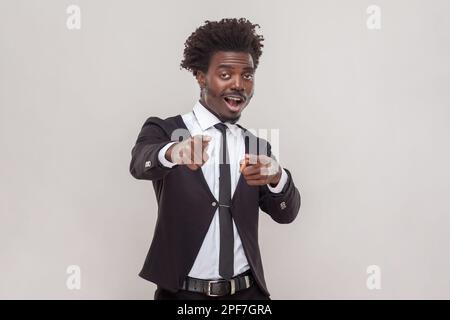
left=0, top=0, right=450, bottom=299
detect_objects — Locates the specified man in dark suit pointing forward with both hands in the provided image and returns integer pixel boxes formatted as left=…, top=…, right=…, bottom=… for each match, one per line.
left=130, top=19, right=300, bottom=300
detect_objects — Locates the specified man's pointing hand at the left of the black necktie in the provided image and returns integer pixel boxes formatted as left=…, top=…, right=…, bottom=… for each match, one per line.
left=165, top=135, right=211, bottom=170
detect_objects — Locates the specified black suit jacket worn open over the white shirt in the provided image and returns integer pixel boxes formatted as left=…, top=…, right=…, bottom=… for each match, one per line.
left=130, top=115, right=300, bottom=296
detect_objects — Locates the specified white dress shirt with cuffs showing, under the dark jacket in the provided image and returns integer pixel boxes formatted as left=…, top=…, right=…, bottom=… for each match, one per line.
left=158, top=102, right=288, bottom=279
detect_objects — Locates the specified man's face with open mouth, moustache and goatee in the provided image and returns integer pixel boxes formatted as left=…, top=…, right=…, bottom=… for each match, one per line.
left=197, top=51, right=255, bottom=123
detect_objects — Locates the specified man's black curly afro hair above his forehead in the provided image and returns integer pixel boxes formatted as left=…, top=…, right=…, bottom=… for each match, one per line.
left=180, top=18, right=264, bottom=76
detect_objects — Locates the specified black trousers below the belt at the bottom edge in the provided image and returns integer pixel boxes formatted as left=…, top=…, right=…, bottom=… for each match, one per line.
left=154, top=283, right=270, bottom=300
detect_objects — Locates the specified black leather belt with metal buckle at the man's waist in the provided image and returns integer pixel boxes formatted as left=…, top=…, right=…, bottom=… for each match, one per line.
left=182, top=270, right=254, bottom=297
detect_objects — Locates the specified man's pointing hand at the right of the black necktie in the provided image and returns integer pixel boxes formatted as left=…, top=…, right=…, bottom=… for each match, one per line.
left=239, top=154, right=281, bottom=187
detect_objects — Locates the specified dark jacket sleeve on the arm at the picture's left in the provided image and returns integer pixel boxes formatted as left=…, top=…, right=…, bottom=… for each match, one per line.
left=130, top=117, right=177, bottom=180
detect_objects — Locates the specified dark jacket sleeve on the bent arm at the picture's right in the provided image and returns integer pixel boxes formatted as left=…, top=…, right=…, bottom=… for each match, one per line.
left=259, top=143, right=301, bottom=223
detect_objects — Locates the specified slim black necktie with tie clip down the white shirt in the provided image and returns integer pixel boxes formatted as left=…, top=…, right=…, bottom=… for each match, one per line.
left=214, top=123, right=234, bottom=280
